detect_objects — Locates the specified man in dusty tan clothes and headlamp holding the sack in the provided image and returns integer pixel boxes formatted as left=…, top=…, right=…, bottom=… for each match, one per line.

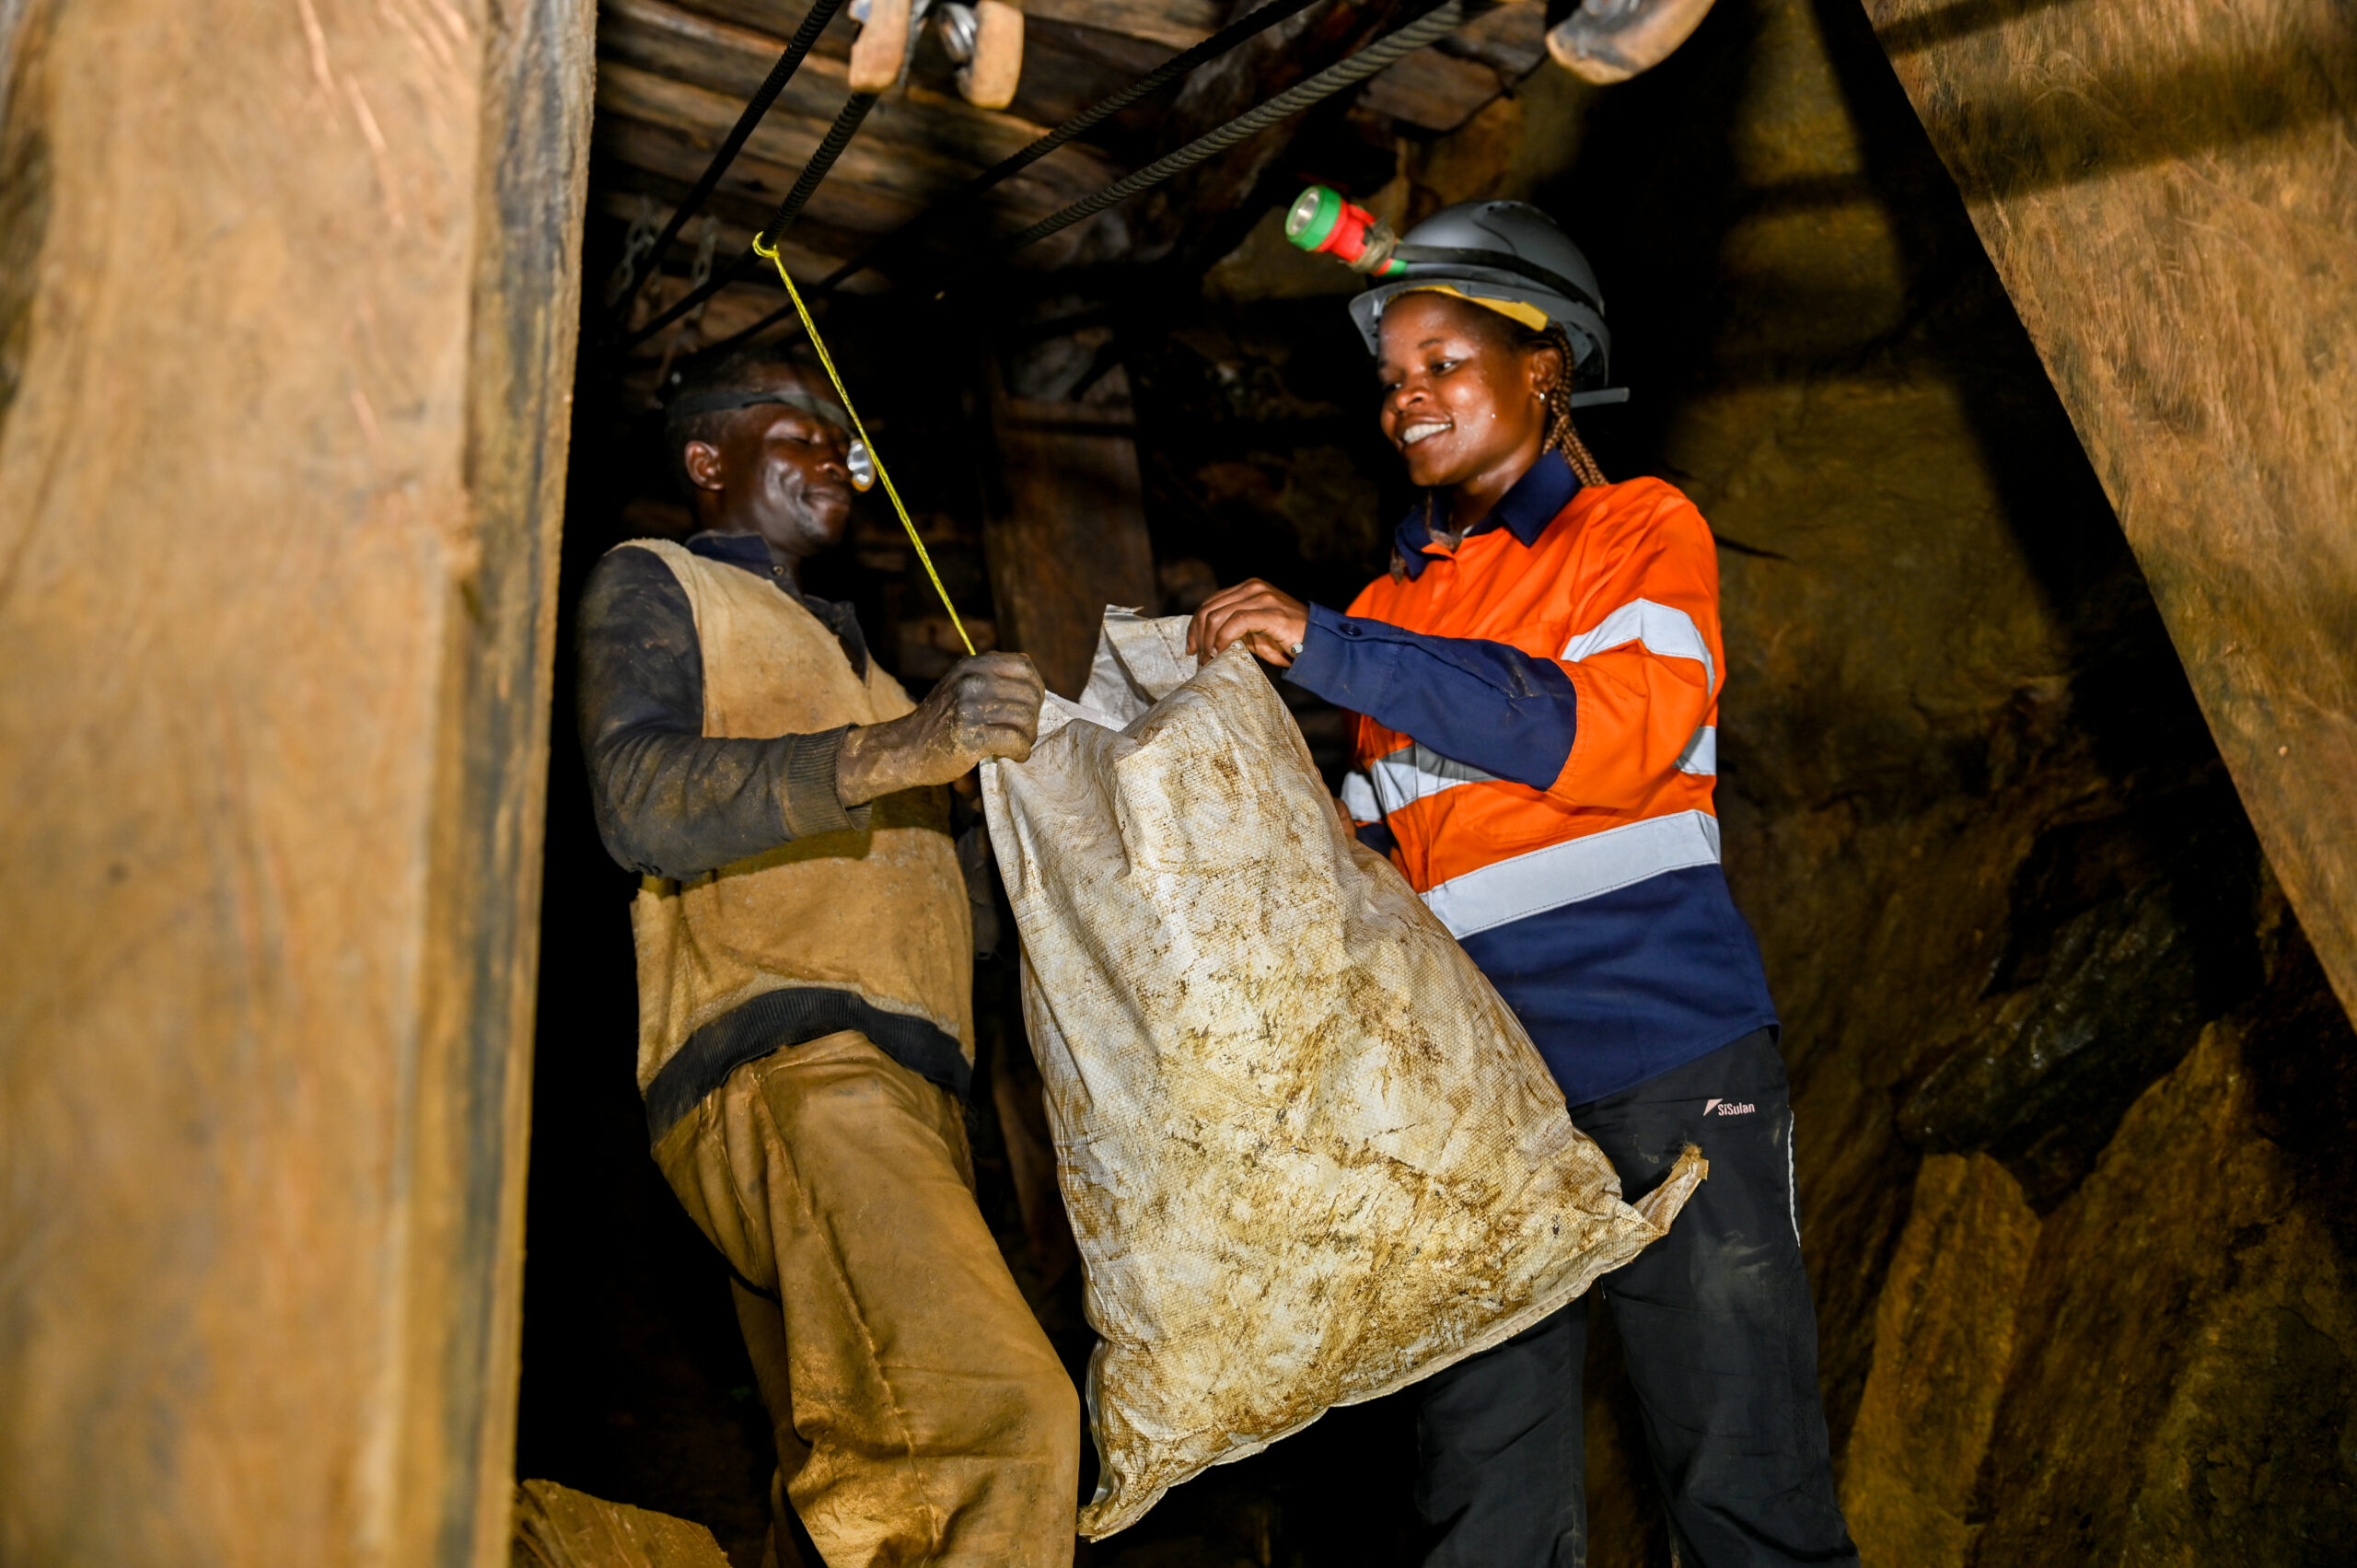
left=580, top=354, right=1079, bottom=1568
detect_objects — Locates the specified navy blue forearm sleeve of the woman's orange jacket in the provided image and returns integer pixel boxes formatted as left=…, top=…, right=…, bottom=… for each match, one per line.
left=1284, top=604, right=1579, bottom=790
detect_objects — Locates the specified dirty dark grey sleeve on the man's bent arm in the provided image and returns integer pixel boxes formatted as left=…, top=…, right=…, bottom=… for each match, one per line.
left=580, top=550, right=867, bottom=879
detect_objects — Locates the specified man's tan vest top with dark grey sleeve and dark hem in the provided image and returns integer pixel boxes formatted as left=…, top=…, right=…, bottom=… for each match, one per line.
left=582, top=535, right=973, bottom=1139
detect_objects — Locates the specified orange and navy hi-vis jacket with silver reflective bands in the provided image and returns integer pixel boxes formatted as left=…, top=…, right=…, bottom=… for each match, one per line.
left=1289, top=453, right=1775, bottom=1104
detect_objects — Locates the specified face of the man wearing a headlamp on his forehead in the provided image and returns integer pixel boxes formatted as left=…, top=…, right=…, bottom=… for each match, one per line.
left=681, top=366, right=851, bottom=559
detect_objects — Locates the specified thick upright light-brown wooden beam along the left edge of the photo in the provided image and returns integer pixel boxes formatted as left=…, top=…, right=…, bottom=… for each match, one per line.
left=0, top=0, right=592, bottom=1568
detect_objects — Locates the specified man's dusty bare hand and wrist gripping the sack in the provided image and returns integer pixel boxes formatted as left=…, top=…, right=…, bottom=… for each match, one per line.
left=834, top=653, right=1047, bottom=807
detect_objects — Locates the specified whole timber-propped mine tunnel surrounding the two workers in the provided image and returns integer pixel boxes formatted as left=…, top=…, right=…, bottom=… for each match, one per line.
left=0, top=0, right=2357, bottom=1568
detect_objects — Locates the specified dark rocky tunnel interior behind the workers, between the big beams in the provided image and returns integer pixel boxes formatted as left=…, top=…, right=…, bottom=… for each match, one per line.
left=517, top=0, right=2357, bottom=1568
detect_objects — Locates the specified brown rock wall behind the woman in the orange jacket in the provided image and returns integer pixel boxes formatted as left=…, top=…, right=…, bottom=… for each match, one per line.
left=1129, top=0, right=2357, bottom=1565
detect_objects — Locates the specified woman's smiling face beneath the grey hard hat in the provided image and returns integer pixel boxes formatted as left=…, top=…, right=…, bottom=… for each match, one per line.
left=1376, top=293, right=1562, bottom=488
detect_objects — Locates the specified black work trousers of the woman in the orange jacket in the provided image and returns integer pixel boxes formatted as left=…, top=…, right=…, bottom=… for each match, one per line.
left=1407, top=1030, right=1857, bottom=1568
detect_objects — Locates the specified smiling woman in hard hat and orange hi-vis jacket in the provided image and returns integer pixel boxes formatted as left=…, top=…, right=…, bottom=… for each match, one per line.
left=1190, top=203, right=1857, bottom=1568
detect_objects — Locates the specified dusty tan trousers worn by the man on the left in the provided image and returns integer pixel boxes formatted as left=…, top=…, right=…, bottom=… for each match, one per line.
left=656, top=1030, right=1079, bottom=1568
